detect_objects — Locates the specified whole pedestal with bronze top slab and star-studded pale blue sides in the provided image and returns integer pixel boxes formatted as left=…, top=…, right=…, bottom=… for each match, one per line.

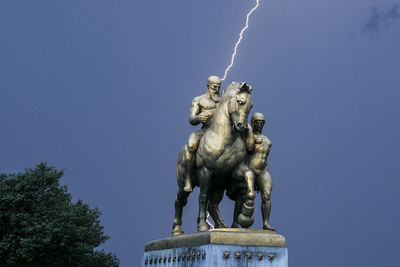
left=142, top=228, right=288, bottom=267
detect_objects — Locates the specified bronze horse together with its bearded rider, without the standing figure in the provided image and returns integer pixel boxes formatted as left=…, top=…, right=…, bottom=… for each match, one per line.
left=172, top=76, right=254, bottom=235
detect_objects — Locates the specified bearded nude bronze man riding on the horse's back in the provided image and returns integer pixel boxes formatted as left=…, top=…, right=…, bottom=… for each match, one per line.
left=183, top=76, right=221, bottom=192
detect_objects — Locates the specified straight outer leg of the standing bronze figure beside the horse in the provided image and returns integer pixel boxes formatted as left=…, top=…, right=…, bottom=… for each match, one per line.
left=257, top=170, right=275, bottom=230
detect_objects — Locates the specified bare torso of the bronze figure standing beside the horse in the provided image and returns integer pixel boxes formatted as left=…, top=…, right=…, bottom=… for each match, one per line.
left=248, top=134, right=272, bottom=175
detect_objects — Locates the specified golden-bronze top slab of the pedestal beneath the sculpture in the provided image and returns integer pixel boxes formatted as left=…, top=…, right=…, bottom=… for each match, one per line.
left=145, top=228, right=286, bottom=252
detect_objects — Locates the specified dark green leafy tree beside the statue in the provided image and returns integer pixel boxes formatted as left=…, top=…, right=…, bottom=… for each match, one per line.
left=0, top=163, right=119, bottom=267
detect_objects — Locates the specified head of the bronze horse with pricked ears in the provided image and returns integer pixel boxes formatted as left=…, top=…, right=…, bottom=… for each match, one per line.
left=224, top=82, right=253, bottom=132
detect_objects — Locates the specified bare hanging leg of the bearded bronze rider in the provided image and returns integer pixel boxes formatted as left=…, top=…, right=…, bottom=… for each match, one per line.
left=184, top=130, right=204, bottom=192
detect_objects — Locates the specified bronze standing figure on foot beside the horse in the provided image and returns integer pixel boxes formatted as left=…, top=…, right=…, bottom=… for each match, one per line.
left=247, top=113, right=275, bottom=230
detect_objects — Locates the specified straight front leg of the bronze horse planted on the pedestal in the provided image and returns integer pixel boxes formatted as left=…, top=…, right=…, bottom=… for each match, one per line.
left=197, top=167, right=211, bottom=232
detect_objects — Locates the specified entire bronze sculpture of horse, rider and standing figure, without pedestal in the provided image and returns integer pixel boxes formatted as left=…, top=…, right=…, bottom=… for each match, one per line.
left=172, top=76, right=273, bottom=235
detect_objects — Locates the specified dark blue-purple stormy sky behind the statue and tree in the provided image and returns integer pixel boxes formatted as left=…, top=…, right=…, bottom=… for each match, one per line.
left=0, top=0, right=400, bottom=267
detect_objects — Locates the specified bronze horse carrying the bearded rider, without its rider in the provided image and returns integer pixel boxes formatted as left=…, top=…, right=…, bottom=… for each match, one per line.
left=172, top=82, right=255, bottom=235
